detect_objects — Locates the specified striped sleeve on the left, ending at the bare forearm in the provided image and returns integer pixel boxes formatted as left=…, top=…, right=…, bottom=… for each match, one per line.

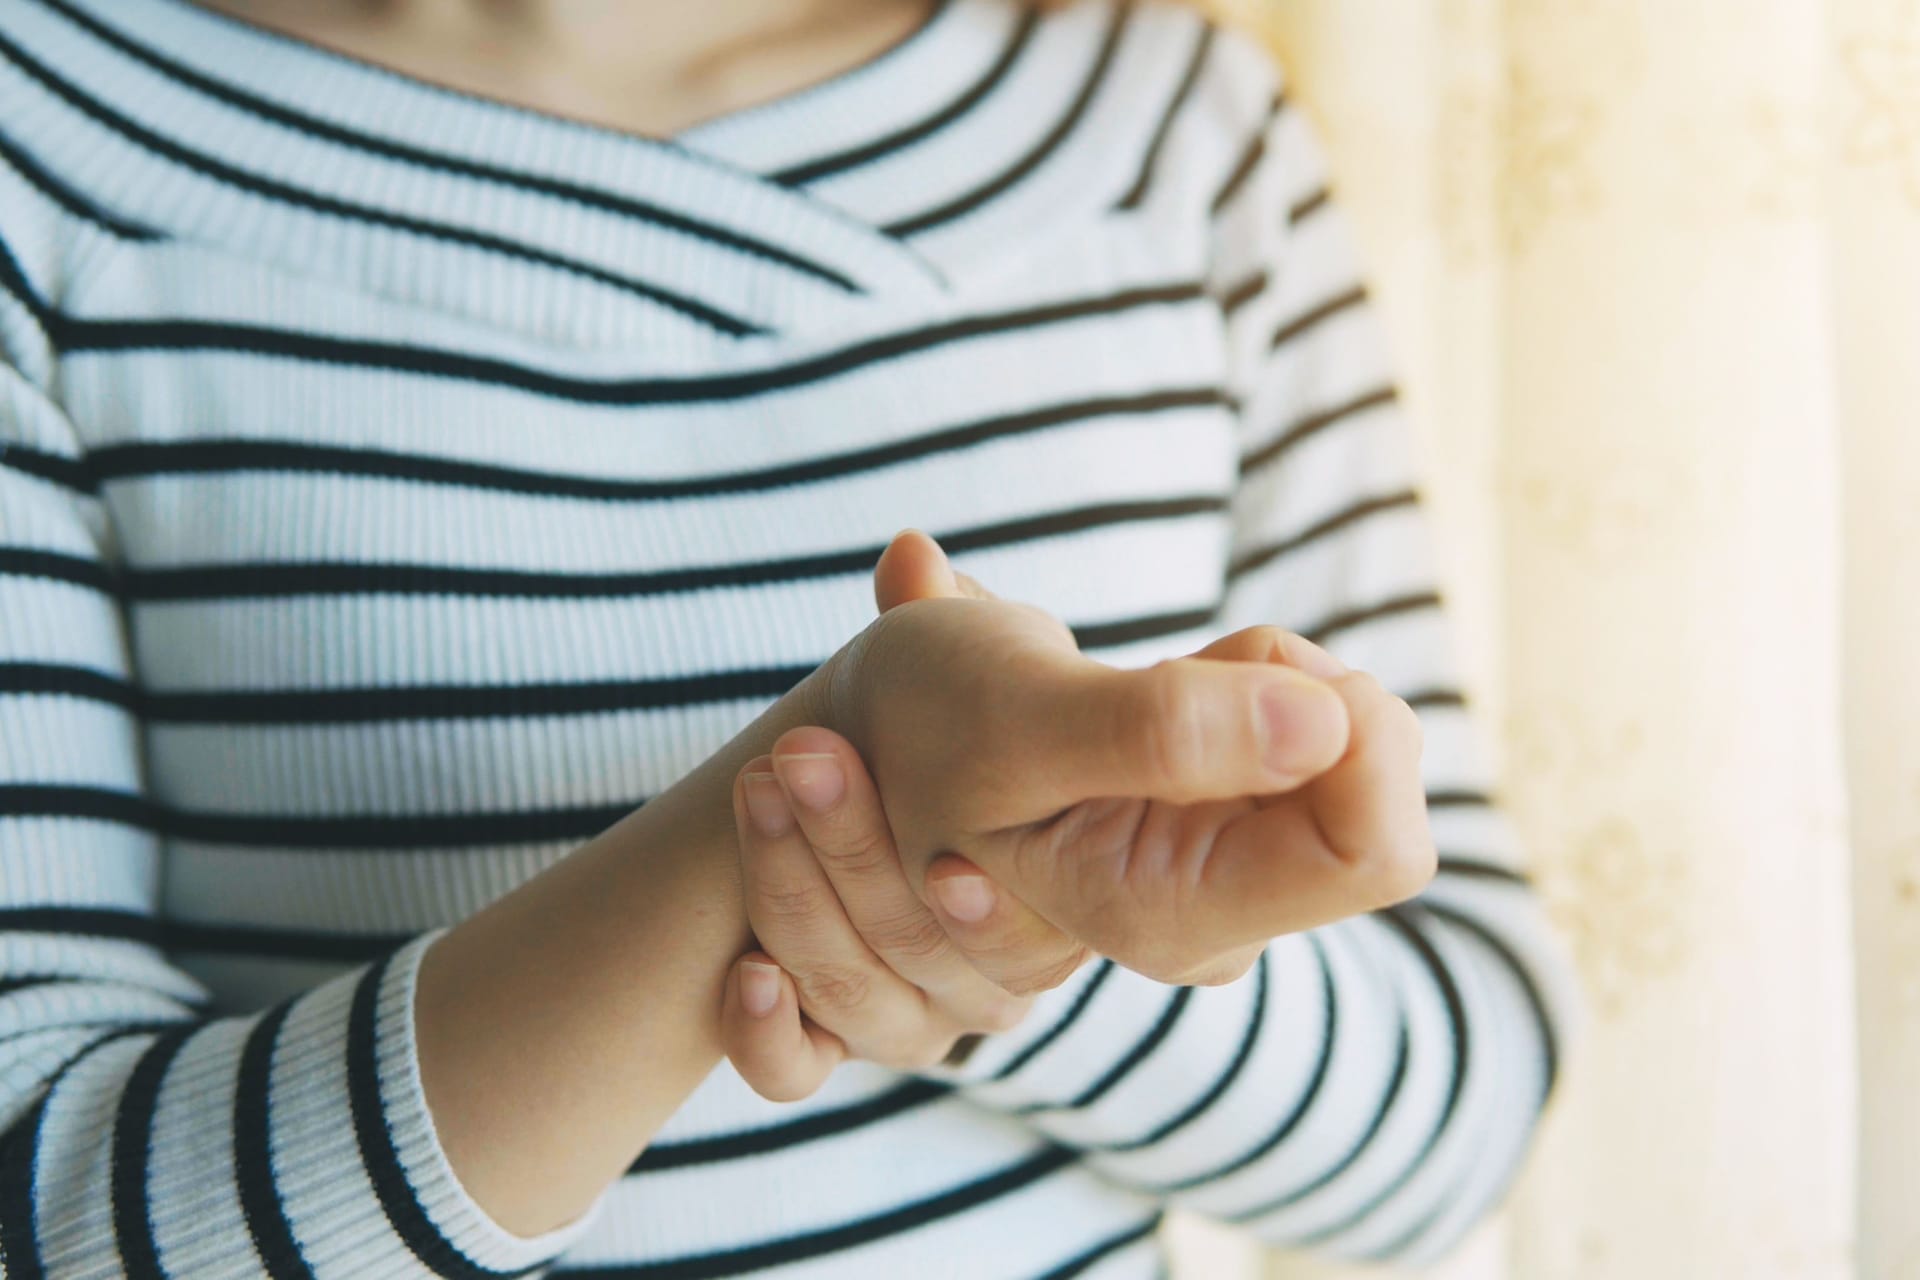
left=0, top=214, right=578, bottom=1280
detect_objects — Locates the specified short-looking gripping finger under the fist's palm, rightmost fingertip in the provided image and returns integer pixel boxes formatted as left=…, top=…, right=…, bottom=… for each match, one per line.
left=925, top=854, right=1092, bottom=997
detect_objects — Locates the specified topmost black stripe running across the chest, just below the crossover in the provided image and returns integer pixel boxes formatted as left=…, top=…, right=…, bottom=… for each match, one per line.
left=44, top=282, right=1204, bottom=405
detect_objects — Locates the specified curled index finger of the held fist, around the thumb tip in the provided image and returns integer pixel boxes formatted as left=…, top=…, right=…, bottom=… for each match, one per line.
left=1200, top=674, right=1436, bottom=940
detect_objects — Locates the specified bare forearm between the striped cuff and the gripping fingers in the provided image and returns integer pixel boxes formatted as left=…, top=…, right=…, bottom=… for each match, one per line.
left=415, top=667, right=833, bottom=1234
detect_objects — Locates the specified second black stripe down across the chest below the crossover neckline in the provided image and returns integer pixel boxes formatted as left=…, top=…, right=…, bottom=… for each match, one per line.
left=88, top=388, right=1227, bottom=501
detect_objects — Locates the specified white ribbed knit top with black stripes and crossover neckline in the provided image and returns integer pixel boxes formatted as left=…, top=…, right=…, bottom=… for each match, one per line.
left=0, top=0, right=1572, bottom=1280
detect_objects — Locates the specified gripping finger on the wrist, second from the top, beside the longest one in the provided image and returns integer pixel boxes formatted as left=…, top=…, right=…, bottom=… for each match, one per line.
left=735, top=756, right=958, bottom=1069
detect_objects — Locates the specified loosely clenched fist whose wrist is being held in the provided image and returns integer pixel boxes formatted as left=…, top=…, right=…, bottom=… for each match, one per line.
left=802, top=537, right=1434, bottom=992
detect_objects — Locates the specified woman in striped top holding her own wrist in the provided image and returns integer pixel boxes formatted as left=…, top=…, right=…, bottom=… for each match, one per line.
left=0, top=0, right=1567, bottom=1276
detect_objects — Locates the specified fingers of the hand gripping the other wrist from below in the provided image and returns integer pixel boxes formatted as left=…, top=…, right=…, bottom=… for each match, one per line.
left=722, top=727, right=1087, bottom=1102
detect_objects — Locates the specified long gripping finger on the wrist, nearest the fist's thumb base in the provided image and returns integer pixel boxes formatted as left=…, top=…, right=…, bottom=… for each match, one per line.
left=772, top=727, right=1036, bottom=1031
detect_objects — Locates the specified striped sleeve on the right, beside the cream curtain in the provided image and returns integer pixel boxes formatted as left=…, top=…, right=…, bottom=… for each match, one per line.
left=925, top=44, right=1574, bottom=1263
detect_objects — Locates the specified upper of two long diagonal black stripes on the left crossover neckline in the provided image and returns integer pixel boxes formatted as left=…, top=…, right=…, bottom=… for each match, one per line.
left=26, top=0, right=858, bottom=292
